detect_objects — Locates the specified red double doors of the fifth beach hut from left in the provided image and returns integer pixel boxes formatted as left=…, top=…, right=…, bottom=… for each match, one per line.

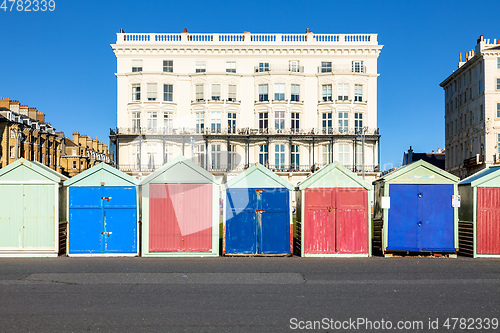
left=304, top=188, right=368, bottom=254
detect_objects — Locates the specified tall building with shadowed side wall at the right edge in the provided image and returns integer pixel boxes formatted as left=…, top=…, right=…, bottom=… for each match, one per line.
left=440, top=35, right=500, bottom=178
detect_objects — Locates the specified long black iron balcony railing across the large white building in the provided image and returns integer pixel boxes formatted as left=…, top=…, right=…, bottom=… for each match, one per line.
left=115, top=127, right=379, bottom=136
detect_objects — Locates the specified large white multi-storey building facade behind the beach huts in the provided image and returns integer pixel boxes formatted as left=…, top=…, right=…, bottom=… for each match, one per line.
left=110, top=31, right=382, bottom=182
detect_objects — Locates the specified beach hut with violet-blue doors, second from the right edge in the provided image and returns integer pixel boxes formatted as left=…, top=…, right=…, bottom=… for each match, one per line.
left=373, top=160, right=459, bottom=256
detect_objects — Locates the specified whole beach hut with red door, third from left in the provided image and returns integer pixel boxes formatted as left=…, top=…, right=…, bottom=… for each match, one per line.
left=141, top=156, right=220, bottom=257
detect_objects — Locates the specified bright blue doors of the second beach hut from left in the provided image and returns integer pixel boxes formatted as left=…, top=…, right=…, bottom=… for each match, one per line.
left=69, top=186, right=137, bottom=253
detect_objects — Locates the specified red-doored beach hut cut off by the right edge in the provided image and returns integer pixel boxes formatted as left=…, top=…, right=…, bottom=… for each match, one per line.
left=458, top=166, right=500, bottom=258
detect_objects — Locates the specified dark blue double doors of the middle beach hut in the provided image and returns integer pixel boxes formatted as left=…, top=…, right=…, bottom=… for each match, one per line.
left=226, top=188, right=290, bottom=254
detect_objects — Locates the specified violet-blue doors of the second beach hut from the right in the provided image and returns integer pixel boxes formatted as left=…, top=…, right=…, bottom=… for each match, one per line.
left=387, top=184, right=455, bottom=251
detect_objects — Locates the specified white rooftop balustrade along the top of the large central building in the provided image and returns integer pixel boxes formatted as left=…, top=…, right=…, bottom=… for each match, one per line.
left=116, top=32, right=378, bottom=45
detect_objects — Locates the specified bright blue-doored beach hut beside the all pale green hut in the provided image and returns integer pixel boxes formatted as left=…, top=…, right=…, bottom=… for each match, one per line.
left=64, top=163, right=139, bottom=256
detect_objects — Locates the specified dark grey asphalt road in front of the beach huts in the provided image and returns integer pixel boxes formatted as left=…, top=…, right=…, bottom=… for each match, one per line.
left=0, top=257, right=500, bottom=332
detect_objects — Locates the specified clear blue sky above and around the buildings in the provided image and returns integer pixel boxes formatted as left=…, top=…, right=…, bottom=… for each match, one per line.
left=0, top=0, right=500, bottom=169
